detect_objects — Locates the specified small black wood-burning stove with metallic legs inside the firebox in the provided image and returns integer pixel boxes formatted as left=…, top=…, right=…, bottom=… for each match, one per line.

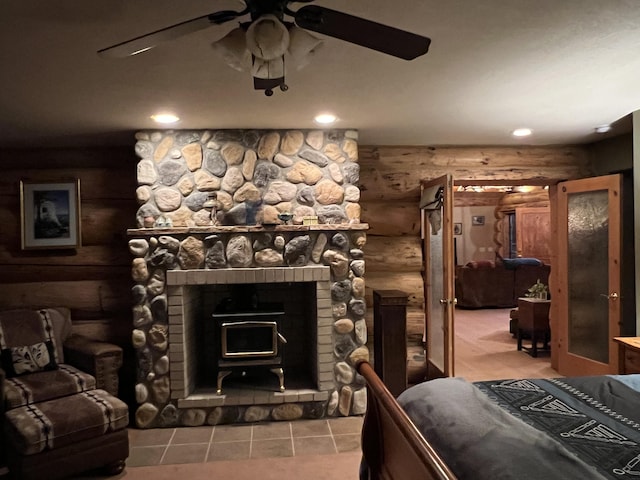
left=212, top=306, right=287, bottom=395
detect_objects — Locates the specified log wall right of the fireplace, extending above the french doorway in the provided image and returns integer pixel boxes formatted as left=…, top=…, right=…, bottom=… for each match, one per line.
left=359, top=145, right=593, bottom=330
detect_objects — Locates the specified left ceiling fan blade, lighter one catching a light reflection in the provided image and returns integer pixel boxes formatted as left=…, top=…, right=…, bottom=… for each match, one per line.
left=98, top=9, right=248, bottom=58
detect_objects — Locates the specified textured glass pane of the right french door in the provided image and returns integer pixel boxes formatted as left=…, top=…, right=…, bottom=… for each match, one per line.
left=567, top=190, right=609, bottom=363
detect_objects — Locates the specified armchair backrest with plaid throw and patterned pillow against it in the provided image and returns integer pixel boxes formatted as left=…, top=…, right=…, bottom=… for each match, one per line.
left=0, top=309, right=63, bottom=377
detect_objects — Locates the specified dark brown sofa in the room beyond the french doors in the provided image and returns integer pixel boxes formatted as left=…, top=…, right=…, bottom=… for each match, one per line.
left=455, top=258, right=551, bottom=308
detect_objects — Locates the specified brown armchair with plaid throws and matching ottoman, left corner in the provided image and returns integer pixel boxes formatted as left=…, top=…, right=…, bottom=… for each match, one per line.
left=0, top=308, right=129, bottom=480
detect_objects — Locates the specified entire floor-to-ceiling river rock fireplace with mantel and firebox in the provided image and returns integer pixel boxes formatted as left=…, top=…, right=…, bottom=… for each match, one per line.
left=128, top=130, right=369, bottom=428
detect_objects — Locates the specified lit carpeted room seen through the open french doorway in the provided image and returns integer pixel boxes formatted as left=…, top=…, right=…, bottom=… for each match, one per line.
left=453, top=182, right=558, bottom=378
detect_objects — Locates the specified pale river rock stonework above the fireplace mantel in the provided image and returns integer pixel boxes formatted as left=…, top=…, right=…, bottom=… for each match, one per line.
left=136, top=130, right=360, bottom=228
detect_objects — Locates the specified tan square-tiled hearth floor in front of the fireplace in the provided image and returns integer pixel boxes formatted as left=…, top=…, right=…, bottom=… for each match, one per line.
left=127, top=417, right=363, bottom=467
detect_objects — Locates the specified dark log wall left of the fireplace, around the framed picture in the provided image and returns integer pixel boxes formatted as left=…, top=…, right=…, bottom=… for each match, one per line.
left=0, top=148, right=138, bottom=348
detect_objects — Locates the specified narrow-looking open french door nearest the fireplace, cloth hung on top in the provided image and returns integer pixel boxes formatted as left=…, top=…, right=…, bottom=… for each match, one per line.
left=420, top=175, right=455, bottom=378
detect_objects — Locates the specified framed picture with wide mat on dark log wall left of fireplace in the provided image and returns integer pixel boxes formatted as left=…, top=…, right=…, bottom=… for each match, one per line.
left=20, top=179, right=81, bottom=250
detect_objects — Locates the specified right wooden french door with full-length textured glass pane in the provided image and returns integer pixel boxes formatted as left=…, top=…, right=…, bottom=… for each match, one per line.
left=552, top=175, right=622, bottom=376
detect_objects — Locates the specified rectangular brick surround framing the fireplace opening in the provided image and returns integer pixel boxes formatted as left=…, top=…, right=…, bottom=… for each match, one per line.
left=167, top=266, right=334, bottom=402
